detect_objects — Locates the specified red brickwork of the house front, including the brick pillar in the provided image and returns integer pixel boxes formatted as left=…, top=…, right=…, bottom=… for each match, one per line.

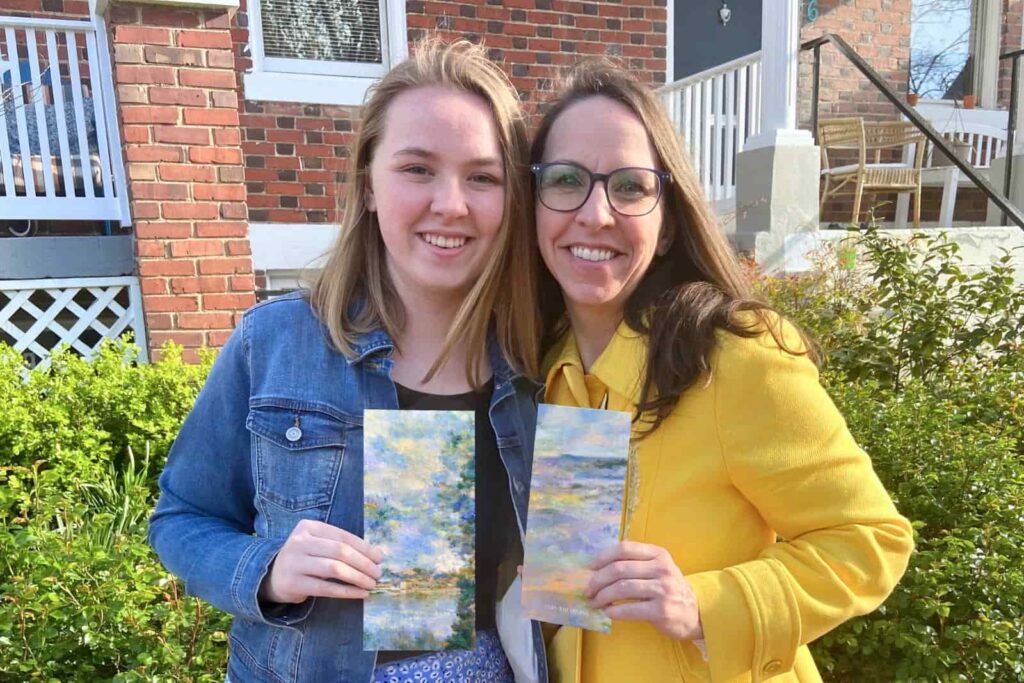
left=6, top=0, right=1024, bottom=349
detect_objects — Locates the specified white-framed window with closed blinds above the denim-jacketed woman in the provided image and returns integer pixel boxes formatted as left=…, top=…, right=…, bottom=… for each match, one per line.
left=245, top=0, right=408, bottom=104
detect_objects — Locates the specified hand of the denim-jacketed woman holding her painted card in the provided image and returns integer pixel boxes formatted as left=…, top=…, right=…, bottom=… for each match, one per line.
left=259, top=519, right=383, bottom=603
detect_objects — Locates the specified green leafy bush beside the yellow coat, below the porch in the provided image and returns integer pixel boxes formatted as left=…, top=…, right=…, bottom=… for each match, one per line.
left=759, top=231, right=1024, bottom=681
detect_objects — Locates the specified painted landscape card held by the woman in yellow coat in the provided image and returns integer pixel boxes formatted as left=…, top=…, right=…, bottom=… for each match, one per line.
left=522, top=404, right=632, bottom=633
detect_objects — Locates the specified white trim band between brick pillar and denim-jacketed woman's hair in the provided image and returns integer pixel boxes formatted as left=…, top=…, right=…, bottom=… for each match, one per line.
left=249, top=223, right=338, bottom=270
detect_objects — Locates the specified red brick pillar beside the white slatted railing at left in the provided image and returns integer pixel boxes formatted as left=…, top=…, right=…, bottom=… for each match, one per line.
left=109, top=3, right=256, bottom=358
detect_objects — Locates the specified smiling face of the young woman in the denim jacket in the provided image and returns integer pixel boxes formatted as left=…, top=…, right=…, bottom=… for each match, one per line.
left=366, top=87, right=505, bottom=303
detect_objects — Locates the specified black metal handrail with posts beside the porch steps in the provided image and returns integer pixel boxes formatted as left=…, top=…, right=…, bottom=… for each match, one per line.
left=800, top=33, right=1024, bottom=230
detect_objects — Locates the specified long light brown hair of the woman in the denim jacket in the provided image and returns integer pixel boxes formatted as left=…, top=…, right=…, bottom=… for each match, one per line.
left=310, top=40, right=540, bottom=387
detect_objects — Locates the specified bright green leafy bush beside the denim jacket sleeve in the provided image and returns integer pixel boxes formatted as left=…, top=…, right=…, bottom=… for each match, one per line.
left=0, top=344, right=228, bottom=681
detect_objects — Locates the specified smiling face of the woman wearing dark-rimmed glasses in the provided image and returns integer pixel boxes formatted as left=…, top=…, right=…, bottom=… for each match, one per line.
left=537, top=95, right=667, bottom=324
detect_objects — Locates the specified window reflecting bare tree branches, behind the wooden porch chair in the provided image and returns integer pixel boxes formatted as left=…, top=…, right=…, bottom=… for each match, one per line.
left=908, top=0, right=1001, bottom=106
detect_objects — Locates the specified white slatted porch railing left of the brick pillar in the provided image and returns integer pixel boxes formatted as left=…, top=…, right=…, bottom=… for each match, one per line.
left=0, top=16, right=130, bottom=224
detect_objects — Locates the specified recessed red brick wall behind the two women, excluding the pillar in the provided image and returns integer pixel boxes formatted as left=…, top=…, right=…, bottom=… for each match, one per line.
left=231, top=0, right=668, bottom=229
